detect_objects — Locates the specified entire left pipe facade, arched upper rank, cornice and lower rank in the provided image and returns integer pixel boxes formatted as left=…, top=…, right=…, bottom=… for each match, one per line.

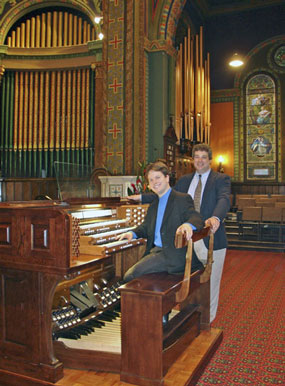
left=0, top=7, right=103, bottom=178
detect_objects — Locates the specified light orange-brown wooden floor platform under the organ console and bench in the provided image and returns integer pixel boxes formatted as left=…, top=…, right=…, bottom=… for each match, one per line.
left=55, top=328, right=222, bottom=386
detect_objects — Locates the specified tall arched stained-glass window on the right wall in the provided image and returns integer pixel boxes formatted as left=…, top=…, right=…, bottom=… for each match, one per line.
left=245, top=73, right=277, bottom=180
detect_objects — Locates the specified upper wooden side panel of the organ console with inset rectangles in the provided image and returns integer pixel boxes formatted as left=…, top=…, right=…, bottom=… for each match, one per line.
left=0, top=209, right=71, bottom=269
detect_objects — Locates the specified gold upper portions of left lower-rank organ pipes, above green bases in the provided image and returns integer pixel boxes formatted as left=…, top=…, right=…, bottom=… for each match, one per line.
left=6, top=68, right=92, bottom=150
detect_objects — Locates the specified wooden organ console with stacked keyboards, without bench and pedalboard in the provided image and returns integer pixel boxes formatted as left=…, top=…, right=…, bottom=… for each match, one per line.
left=0, top=199, right=146, bottom=384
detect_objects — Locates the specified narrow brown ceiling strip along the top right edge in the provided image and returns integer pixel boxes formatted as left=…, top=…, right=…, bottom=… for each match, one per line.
left=187, top=0, right=284, bottom=17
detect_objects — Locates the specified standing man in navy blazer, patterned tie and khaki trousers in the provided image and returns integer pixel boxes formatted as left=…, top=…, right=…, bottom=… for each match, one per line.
left=129, top=144, right=231, bottom=322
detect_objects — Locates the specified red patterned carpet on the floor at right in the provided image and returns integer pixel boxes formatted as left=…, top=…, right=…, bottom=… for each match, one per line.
left=197, top=250, right=285, bottom=386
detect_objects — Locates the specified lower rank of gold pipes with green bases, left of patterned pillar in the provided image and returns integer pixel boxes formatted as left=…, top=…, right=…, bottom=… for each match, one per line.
left=1, top=68, right=95, bottom=177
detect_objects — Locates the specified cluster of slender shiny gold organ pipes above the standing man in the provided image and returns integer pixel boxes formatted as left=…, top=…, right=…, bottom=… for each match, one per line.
left=176, top=27, right=211, bottom=143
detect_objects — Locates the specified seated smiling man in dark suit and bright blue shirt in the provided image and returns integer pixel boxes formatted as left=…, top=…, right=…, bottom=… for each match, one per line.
left=119, top=162, right=204, bottom=282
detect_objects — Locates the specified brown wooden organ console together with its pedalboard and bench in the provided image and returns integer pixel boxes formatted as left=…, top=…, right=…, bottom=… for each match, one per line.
left=0, top=198, right=222, bottom=386
